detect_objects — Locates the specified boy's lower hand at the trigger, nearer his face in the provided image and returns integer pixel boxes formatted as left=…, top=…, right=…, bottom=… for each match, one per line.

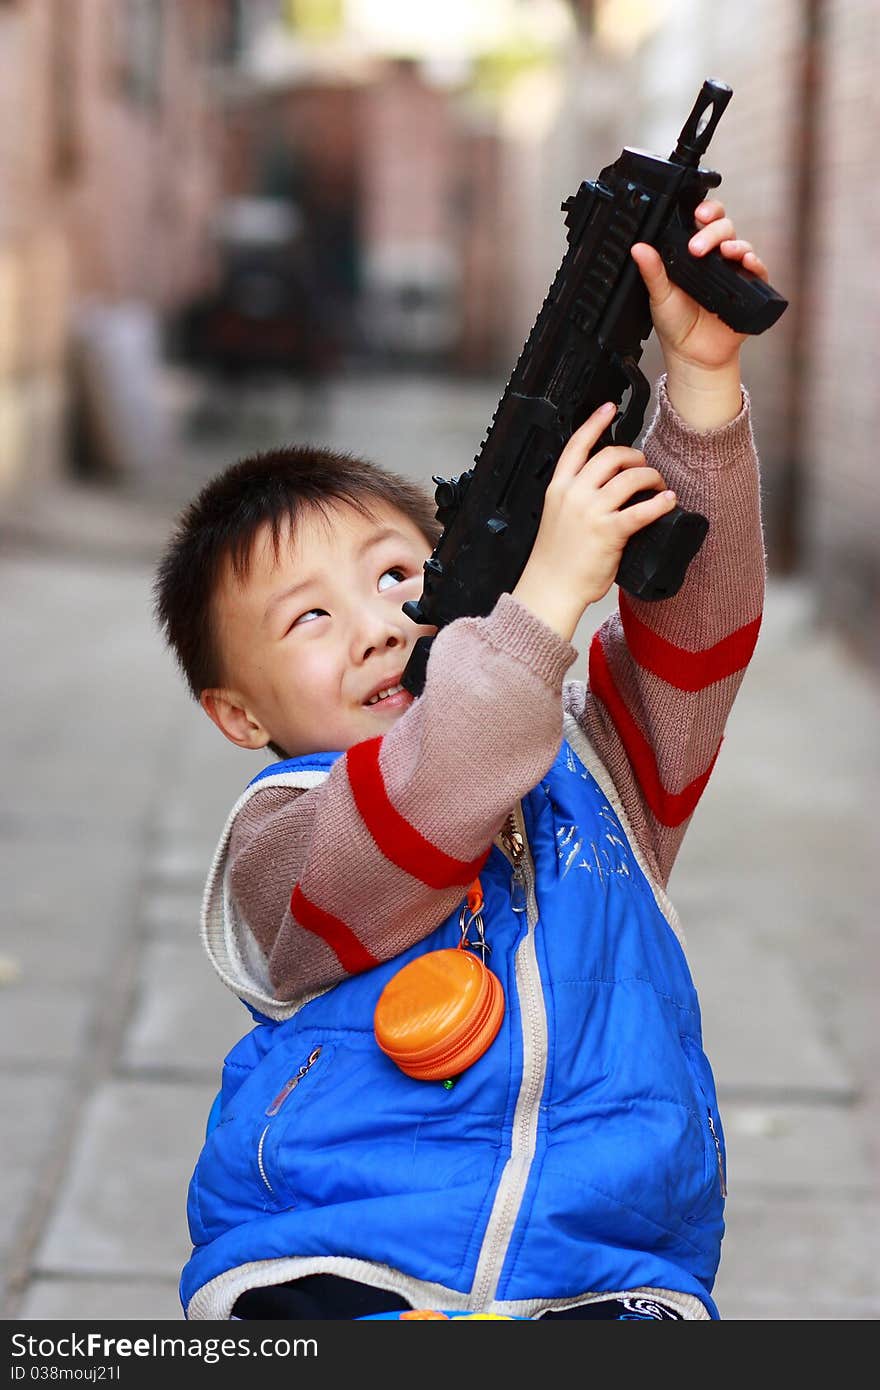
left=513, top=402, right=676, bottom=641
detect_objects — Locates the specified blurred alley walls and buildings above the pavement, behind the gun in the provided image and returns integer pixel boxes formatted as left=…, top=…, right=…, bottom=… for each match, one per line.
left=0, top=0, right=880, bottom=617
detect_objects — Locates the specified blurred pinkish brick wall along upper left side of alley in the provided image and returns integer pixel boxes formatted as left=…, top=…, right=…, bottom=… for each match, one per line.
left=0, top=0, right=224, bottom=492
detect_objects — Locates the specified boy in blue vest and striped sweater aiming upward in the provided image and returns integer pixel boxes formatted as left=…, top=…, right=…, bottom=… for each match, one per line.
left=157, top=202, right=767, bottom=1319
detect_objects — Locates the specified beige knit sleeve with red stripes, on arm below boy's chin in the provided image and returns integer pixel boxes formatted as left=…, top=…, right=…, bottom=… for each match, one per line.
left=229, top=594, right=577, bottom=999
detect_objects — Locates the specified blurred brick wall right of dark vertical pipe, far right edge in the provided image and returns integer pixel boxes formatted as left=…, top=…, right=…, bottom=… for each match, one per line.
left=801, top=0, right=880, bottom=667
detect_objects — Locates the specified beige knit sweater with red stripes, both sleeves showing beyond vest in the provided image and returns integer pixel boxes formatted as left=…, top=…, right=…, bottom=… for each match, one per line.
left=219, top=379, right=765, bottom=1001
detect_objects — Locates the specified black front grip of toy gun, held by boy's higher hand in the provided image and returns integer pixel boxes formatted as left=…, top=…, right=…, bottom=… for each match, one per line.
left=658, top=227, right=788, bottom=334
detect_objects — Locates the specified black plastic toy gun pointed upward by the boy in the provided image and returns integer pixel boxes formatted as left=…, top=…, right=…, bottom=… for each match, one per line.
left=402, top=79, right=787, bottom=695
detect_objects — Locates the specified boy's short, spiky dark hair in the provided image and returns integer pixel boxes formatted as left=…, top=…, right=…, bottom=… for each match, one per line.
left=153, top=446, right=441, bottom=699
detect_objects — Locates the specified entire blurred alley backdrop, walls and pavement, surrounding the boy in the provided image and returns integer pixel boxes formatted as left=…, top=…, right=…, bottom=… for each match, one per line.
left=0, top=0, right=880, bottom=1318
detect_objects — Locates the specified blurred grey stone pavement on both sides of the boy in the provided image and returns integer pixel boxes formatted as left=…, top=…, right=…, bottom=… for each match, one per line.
left=0, top=366, right=880, bottom=1321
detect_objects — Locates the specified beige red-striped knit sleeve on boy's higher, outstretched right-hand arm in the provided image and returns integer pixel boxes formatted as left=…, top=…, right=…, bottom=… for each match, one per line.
left=564, top=378, right=765, bottom=885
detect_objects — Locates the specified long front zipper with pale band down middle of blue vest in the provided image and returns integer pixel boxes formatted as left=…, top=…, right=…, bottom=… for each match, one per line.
left=470, top=805, right=546, bottom=1309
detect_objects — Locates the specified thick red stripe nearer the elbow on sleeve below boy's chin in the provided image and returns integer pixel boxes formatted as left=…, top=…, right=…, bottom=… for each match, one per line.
left=345, top=737, right=491, bottom=888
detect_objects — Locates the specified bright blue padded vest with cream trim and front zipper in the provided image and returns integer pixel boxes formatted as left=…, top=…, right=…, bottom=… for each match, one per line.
left=181, top=719, right=724, bottom=1318
